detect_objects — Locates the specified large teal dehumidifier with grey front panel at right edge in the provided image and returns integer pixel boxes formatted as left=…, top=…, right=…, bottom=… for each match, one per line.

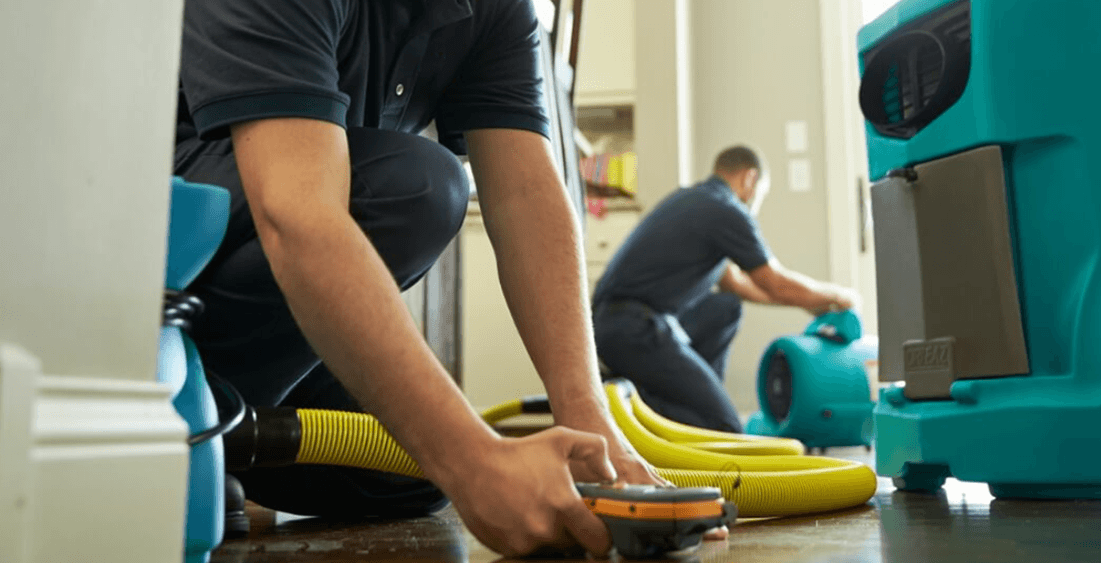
left=859, top=0, right=1101, bottom=498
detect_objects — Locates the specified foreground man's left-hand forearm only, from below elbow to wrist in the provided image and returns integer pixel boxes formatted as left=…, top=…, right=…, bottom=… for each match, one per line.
left=257, top=211, right=493, bottom=477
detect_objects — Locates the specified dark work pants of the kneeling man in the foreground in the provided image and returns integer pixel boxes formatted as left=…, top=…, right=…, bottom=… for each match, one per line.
left=175, top=128, right=470, bottom=518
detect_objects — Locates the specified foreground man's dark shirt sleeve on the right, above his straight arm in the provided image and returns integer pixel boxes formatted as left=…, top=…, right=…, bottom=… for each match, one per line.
left=436, top=0, right=551, bottom=153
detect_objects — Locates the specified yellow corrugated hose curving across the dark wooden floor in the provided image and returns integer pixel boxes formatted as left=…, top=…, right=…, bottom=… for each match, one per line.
left=296, top=382, right=876, bottom=518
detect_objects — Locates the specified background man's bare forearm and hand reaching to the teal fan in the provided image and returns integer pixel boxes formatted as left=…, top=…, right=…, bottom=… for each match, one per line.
left=749, top=259, right=858, bottom=315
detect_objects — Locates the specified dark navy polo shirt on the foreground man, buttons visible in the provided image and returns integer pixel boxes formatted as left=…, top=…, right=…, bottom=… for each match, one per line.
left=176, top=0, right=549, bottom=154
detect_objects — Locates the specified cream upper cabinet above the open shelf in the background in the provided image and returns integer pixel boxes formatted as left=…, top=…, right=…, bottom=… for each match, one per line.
left=574, top=0, right=635, bottom=106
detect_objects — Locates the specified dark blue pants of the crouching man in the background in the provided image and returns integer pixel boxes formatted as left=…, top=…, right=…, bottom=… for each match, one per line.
left=593, top=293, right=742, bottom=432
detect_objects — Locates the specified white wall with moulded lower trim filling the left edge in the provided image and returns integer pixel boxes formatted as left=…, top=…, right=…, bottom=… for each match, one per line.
left=0, top=0, right=187, bottom=563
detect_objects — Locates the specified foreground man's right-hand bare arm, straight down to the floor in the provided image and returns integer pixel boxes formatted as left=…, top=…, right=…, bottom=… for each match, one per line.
left=466, top=129, right=662, bottom=483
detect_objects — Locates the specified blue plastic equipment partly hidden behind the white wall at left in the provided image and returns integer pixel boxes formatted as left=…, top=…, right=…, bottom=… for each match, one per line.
left=157, top=177, right=229, bottom=563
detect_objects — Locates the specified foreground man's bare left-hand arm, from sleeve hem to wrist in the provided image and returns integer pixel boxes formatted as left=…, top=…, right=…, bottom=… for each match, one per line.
left=232, top=119, right=495, bottom=486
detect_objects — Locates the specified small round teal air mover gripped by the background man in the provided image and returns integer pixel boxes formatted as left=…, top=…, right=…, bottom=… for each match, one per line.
left=745, top=311, right=876, bottom=447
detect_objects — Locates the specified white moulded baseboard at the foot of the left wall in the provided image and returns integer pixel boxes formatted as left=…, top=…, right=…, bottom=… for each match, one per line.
left=0, top=343, right=188, bottom=563
